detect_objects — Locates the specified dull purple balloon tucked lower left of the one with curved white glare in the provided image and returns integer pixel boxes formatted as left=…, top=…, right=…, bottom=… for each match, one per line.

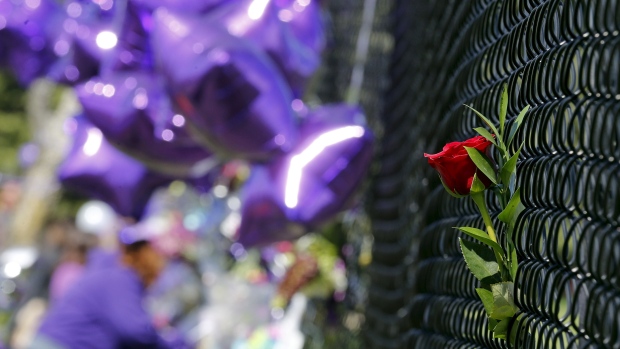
left=237, top=165, right=307, bottom=247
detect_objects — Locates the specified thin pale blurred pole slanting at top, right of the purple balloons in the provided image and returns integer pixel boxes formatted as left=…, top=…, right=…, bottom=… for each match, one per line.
left=346, top=0, right=377, bottom=104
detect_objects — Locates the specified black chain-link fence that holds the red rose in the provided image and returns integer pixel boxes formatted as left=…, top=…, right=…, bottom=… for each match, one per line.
left=363, top=0, right=620, bottom=349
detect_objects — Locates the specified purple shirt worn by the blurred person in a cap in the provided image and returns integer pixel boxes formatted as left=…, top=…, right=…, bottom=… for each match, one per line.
left=39, top=262, right=177, bottom=349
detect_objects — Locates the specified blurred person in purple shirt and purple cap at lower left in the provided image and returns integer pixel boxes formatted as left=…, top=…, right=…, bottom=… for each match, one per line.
left=29, top=226, right=188, bottom=349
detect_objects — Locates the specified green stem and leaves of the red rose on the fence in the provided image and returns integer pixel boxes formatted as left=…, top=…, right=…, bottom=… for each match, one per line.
left=432, top=85, right=529, bottom=342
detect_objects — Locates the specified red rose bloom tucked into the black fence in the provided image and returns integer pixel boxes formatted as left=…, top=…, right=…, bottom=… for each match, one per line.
left=424, top=136, right=492, bottom=195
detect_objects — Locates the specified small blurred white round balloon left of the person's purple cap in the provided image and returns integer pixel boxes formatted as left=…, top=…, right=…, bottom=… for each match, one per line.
left=75, top=200, right=117, bottom=235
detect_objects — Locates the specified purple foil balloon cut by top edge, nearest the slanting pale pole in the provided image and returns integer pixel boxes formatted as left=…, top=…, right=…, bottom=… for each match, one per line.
left=207, top=0, right=325, bottom=96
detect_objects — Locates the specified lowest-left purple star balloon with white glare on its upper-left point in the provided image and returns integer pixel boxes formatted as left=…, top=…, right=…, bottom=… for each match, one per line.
left=58, top=117, right=171, bottom=219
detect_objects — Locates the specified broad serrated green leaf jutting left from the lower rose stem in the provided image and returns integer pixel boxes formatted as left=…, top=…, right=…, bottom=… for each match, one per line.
left=459, top=239, right=502, bottom=284
